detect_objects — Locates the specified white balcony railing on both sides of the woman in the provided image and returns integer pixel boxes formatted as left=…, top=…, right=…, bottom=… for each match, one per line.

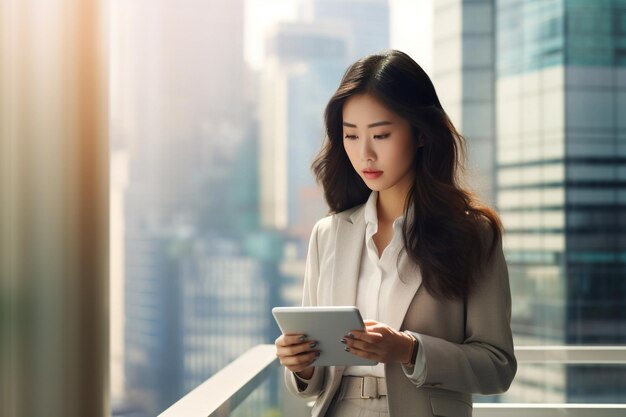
left=159, top=345, right=626, bottom=417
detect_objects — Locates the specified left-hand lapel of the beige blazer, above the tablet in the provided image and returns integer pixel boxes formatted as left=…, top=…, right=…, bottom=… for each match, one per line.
left=330, top=206, right=365, bottom=306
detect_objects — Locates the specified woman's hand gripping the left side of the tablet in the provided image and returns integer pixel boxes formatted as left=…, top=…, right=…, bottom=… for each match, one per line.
left=274, top=334, right=320, bottom=379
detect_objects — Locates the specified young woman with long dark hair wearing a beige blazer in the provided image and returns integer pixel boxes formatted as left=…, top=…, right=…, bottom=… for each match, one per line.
left=276, top=50, right=517, bottom=417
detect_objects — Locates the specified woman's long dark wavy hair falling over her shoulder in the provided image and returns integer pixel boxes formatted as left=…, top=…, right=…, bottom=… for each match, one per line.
left=312, top=50, right=502, bottom=299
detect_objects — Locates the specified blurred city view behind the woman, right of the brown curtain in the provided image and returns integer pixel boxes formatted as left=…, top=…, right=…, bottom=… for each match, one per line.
left=110, top=0, right=626, bottom=415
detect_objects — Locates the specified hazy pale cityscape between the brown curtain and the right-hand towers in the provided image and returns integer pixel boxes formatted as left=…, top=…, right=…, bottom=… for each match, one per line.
left=110, top=0, right=433, bottom=416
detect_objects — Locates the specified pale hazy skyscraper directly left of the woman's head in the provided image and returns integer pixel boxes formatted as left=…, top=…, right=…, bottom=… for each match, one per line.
left=259, top=22, right=346, bottom=244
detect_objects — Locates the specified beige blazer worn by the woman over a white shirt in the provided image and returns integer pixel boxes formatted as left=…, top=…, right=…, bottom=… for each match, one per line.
left=285, top=201, right=517, bottom=417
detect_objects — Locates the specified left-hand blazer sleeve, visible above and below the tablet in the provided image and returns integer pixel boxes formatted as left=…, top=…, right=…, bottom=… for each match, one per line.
left=284, top=219, right=326, bottom=398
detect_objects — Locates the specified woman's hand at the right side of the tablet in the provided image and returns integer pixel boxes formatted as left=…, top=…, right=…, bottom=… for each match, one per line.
left=342, top=320, right=414, bottom=363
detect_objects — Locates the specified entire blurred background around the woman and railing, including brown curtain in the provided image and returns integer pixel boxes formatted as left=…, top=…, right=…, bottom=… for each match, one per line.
left=0, top=0, right=626, bottom=417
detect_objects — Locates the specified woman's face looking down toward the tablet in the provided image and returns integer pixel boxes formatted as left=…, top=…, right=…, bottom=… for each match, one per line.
left=342, top=94, right=418, bottom=195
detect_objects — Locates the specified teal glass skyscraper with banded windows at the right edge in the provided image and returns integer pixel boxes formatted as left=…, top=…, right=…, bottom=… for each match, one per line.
left=496, top=0, right=626, bottom=402
